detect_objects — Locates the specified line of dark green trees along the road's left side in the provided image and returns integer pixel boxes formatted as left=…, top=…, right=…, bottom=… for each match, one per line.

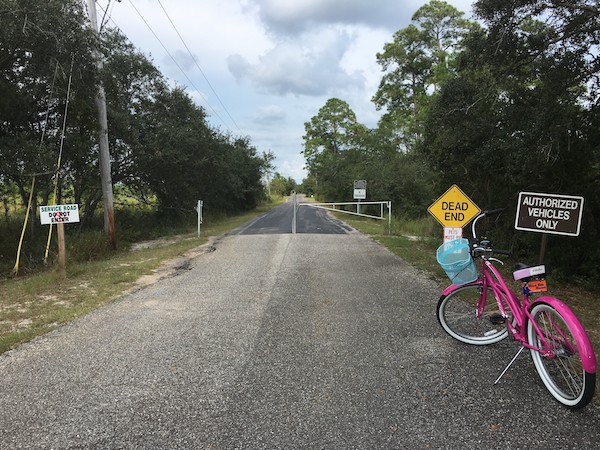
left=0, top=0, right=273, bottom=232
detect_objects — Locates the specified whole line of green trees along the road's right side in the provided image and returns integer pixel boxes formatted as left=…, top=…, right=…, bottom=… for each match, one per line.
left=304, top=0, right=600, bottom=280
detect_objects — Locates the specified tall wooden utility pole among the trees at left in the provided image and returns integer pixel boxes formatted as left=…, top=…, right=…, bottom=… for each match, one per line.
left=88, top=0, right=117, bottom=250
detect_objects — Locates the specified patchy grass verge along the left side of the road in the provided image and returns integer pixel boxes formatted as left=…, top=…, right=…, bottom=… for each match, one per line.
left=0, top=199, right=283, bottom=353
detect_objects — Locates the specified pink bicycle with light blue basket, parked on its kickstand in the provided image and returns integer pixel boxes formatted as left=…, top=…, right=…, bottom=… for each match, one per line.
left=437, top=210, right=597, bottom=409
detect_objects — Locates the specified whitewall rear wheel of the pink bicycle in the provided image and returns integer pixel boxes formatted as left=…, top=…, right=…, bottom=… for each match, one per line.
left=527, top=302, right=596, bottom=409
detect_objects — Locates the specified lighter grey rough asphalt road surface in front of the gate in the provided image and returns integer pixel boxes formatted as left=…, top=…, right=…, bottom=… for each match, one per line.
left=0, top=202, right=600, bottom=449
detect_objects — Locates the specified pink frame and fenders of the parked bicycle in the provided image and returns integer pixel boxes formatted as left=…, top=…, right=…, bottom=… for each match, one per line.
left=443, top=256, right=597, bottom=372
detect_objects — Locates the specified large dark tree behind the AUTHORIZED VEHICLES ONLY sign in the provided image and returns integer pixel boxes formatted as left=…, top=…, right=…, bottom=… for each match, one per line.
left=419, top=0, right=600, bottom=280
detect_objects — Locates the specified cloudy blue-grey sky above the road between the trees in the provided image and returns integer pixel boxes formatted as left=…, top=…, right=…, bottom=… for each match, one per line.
left=96, top=0, right=474, bottom=183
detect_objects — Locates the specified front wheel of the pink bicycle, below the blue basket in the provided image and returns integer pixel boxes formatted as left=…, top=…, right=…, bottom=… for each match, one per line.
left=437, top=284, right=508, bottom=345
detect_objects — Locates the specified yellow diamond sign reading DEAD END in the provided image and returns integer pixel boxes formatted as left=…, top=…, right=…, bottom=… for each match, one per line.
left=427, top=184, right=481, bottom=228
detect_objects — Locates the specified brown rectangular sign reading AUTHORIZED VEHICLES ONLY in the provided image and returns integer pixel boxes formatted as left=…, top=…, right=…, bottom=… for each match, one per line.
left=515, top=192, right=583, bottom=236
